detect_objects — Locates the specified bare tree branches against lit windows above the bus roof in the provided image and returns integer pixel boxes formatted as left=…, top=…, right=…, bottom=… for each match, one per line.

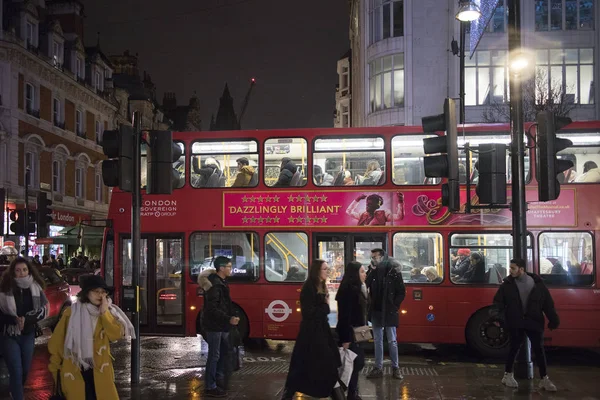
left=481, top=68, right=577, bottom=123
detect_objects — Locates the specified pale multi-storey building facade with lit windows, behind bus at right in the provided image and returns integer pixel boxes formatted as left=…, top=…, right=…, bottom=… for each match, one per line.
left=350, top=0, right=600, bottom=126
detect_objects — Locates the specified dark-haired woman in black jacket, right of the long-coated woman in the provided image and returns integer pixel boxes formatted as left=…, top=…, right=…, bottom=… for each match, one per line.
left=335, top=261, right=367, bottom=400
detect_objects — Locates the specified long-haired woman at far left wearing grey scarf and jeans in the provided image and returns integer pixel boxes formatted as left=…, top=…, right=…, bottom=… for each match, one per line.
left=0, top=257, right=48, bottom=400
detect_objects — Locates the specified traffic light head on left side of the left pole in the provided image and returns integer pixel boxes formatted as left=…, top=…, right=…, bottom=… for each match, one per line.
left=102, top=125, right=134, bottom=192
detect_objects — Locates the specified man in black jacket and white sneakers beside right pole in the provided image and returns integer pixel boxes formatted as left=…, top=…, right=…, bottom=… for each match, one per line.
left=493, top=259, right=560, bottom=392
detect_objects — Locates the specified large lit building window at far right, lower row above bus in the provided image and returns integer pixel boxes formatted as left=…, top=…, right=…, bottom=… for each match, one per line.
left=535, top=49, right=595, bottom=104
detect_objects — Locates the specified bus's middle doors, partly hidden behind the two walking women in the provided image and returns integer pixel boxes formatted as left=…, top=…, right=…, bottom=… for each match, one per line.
left=313, top=232, right=387, bottom=326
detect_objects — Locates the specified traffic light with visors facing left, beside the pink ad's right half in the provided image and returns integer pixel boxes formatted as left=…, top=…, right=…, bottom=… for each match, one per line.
left=422, top=98, right=460, bottom=211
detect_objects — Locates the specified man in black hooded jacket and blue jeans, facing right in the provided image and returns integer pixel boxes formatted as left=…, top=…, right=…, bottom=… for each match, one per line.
left=198, top=256, right=240, bottom=397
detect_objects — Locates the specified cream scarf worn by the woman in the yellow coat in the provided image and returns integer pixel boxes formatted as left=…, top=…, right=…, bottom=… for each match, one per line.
left=64, top=298, right=135, bottom=369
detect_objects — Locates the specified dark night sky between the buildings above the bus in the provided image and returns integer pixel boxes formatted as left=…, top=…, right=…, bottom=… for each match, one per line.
left=83, top=0, right=349, bottom=130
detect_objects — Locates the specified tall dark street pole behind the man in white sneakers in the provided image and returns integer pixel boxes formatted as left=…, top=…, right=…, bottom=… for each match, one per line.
left=508, top=0, right=533, bottom=379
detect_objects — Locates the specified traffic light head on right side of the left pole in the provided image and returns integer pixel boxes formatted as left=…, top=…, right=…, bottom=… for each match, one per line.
left=146, top=131, right=183, bottom=194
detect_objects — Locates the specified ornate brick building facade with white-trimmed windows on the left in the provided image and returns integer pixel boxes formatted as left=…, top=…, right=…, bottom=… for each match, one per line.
left=0, top=0, right=118, bottom=252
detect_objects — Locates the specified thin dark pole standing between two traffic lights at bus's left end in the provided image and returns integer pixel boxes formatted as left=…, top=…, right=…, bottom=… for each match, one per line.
left=131, top=113, right=142, bottom=383
